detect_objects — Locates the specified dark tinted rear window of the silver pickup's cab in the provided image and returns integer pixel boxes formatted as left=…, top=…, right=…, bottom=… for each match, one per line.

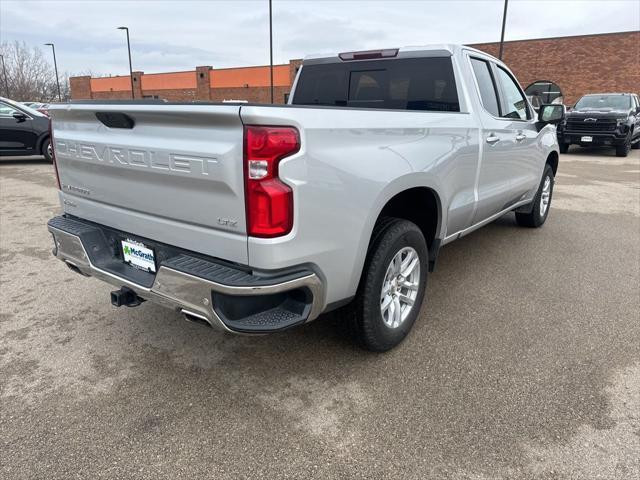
left=293, top=57, right=460, bottom=112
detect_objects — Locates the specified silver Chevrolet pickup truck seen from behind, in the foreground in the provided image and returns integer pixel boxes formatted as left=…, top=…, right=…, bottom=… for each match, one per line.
left=48, top=45, right=564, bottom=351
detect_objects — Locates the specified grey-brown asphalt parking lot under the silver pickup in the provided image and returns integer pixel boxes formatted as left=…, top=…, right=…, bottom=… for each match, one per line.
left=0, top=149, right=640, bottom=480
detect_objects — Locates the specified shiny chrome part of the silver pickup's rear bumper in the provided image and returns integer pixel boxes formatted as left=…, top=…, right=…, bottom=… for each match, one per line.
left=48, top=217, right=323, bottom=333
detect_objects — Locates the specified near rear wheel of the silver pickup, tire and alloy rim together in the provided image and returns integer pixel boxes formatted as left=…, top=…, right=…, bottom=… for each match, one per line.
left=342, top=218, right=429, bottom=352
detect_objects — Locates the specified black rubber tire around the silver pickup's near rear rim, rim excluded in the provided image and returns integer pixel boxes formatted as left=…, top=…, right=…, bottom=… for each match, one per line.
left=340, top=218, right=429, bottom=352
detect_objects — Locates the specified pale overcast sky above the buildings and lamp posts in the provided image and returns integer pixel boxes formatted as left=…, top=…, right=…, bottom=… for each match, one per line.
left=0, top=0, right=640, bottom=75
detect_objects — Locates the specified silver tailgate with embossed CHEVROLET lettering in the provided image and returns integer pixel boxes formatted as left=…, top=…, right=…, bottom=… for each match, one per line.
left=51, top=103, right=247, bottom=263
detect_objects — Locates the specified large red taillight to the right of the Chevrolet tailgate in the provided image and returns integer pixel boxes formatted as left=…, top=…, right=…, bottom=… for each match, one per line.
left=244, top=125, right=300, bottom=238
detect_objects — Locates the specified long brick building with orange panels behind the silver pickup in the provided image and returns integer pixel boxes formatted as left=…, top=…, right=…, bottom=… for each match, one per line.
left=69, top=31, right=640, bottom=104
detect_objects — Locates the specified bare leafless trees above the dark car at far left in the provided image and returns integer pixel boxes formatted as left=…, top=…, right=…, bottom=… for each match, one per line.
left=0, top=40, right=69, bottom=102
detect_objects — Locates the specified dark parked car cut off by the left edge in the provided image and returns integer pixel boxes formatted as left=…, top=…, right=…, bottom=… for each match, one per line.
left=0, top=97, right=52, bottom=161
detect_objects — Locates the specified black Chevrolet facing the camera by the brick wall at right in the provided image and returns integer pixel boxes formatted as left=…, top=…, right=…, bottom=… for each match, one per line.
left=558, top=93, right=640, bottom=157
